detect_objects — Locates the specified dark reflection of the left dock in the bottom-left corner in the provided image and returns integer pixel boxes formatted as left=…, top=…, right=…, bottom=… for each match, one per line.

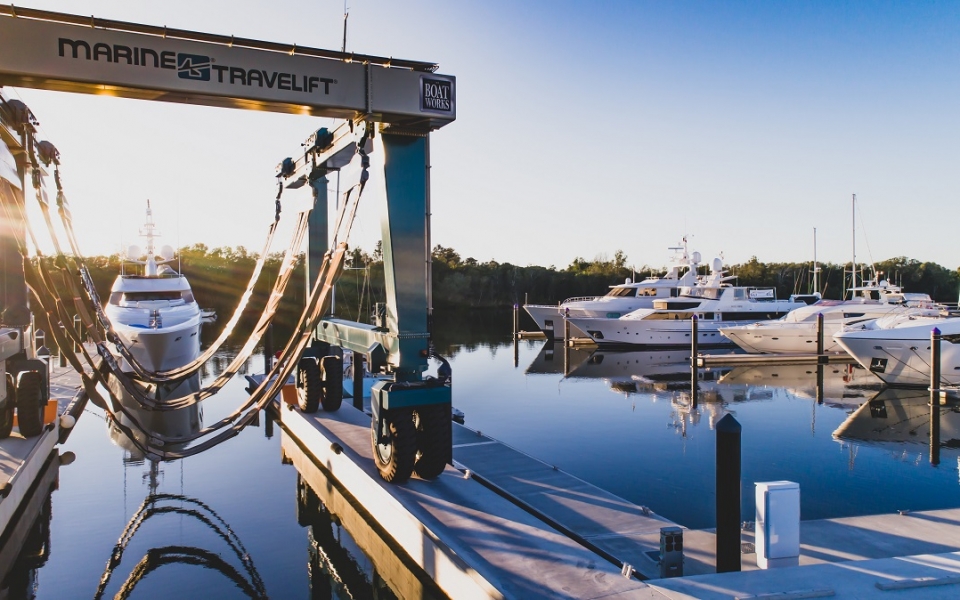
left=0, top=451, right=58, bottom=598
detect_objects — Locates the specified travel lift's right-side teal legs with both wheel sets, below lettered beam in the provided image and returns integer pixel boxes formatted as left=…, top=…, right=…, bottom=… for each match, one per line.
left=278, top=124, right=452, bottom=483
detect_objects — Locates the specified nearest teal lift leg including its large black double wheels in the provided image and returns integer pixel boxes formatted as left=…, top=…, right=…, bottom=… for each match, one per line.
left=370, top=133, right=452, bottom=482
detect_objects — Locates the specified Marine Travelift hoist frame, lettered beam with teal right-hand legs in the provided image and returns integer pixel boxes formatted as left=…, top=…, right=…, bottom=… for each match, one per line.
left=0, top=5, right=456, bottom=481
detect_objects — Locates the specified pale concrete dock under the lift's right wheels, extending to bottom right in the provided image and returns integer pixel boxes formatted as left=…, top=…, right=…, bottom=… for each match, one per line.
left=274, top=396, right=960, bottom=599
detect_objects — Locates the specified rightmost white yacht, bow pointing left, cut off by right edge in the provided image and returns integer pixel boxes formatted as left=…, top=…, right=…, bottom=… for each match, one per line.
left=833, top=312, right=960, bottom=387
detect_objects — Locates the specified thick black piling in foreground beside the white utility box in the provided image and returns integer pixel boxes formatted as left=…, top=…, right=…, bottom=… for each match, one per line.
left=717, top=413, right=742, bottom=573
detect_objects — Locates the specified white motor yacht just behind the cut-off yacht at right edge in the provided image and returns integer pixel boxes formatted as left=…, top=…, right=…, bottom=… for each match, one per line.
left=720, top=279, right=939, bottom=354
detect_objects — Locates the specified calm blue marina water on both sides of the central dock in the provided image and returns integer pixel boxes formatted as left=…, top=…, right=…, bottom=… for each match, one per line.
left=2, top=314, right=960, bottom=599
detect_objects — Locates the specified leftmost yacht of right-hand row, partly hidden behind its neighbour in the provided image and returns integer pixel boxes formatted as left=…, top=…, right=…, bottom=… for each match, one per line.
left=523, top=239, right=700, bottom=337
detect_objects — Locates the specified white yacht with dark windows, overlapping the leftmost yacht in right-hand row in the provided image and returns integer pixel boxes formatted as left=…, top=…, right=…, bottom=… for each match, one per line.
left=570, top=258, right=806, bottom=347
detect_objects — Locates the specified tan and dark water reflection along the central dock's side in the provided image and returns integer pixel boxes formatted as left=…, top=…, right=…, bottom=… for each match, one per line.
left=280, top=432, right=446, bottom=599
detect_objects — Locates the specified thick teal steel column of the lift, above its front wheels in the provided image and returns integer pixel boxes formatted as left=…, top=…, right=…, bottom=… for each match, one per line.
left=380, top=134, right=430, bottom=381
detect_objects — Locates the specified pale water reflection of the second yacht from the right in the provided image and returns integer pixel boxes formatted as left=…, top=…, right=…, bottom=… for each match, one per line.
left=720, top=365, right=883, bottom=407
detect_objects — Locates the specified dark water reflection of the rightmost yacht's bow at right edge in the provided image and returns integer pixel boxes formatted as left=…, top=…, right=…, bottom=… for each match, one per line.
left=833, top=388, right=960, bottom=448
